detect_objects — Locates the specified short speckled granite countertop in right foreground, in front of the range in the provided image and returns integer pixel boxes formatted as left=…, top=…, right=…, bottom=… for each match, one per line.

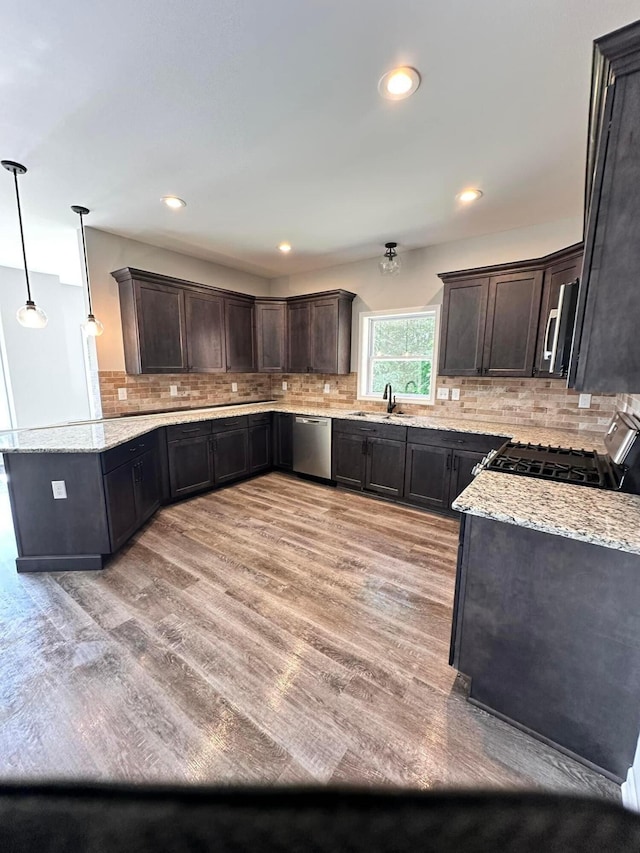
left=453, top=471, right=640, bottom=554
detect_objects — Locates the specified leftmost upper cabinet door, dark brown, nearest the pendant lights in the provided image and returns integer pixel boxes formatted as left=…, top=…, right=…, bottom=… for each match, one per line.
left=136, top=281, right=187, bottom=373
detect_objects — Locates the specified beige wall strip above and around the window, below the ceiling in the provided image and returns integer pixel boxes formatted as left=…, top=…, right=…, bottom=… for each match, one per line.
left=271, top=218, right=582, bottom=370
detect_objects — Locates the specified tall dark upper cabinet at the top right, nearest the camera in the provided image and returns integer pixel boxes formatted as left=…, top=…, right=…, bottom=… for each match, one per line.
left=569, top=21, right=640, bottom=394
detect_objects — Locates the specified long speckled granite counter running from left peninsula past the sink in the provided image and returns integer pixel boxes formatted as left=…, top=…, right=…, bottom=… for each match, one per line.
left=0, top=402, right=602, bottom=453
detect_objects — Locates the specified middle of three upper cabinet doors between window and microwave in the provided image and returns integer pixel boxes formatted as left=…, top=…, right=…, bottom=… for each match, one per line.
left=482, top=270, right=542, bottom=376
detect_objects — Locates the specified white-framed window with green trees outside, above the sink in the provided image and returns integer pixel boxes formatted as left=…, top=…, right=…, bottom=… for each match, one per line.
left=358, top=305, right=440, bottom=405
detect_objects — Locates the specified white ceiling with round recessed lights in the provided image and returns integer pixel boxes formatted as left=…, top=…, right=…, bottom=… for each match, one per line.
left=0, top=0, right=640, bottom=280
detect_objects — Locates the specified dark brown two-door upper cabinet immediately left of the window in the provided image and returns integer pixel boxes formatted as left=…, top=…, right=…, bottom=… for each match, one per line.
left=287, top=290, right=355, bottom=373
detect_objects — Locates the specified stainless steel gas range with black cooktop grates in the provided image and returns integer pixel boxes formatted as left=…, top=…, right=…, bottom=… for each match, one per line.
left=474, top=412, right=640, bottom=494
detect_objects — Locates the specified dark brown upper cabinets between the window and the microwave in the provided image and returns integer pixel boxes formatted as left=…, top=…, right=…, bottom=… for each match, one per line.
left=438, top=244, right=582, bottom=377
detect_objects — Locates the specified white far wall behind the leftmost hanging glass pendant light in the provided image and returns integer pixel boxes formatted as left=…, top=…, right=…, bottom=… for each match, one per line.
left=0, top=267, right=89, bottom=428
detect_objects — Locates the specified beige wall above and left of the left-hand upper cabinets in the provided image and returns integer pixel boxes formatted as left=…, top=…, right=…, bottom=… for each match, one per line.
left=86, top=228, right=269, bottom=370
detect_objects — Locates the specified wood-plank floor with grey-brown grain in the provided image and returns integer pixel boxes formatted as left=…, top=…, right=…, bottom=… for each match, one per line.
left=0, top=473, right=619, bottom=798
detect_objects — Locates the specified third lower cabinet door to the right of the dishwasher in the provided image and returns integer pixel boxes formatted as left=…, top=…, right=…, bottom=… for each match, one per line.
left=404, top=443, right=451, bottom=509
